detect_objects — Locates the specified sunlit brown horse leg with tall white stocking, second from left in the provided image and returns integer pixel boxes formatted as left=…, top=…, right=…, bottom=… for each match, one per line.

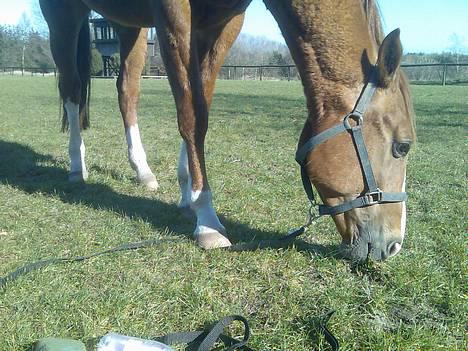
left=116, top=26, right=159, bottom=190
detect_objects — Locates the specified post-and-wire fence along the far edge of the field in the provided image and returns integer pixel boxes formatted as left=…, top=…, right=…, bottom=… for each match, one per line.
left=0, top=63, right=468, bottom=85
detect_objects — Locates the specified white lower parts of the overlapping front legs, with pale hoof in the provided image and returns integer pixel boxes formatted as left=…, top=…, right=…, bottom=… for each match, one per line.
left=177, top=142, right=231, bottom=249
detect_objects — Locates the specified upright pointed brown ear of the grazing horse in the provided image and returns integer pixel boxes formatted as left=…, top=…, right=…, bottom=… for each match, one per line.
left=377, top=29, right=403, bottom=87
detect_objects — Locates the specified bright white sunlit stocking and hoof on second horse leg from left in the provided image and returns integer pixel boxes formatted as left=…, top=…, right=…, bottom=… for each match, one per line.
left=125, top=124, right=159, bottom=190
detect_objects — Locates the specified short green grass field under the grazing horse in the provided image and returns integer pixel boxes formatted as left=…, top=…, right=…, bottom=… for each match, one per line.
left=0, top=77, right=468, bottom=351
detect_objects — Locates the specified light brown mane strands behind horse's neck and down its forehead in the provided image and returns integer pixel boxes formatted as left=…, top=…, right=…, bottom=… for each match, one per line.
left=361, top=0, right=416, bottom=137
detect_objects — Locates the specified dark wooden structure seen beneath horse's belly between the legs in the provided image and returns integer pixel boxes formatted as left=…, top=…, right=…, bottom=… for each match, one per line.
left=90, top=17, right=155, bottom=77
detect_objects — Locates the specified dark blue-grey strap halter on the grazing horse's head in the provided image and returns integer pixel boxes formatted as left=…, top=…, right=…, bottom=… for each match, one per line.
left=296, top=67, right=408, bottom=216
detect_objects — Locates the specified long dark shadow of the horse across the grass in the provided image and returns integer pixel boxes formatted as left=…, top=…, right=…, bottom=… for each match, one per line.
left=0, top=141, right=339, bottom=257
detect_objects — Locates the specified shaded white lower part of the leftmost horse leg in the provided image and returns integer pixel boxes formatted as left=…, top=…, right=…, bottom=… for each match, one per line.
left=64, top=100, right=88, bottom=182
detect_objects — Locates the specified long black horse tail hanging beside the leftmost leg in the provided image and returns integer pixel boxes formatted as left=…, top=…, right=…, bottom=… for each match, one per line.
left=62, top=17, right=91, bottom=131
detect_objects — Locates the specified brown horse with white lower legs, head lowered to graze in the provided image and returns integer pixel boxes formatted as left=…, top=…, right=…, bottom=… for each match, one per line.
left=41, top=0, right=415, bottom=260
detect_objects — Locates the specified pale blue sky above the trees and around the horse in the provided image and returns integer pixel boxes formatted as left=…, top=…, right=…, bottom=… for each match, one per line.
left=0, top=0, right=468, bottom=53
